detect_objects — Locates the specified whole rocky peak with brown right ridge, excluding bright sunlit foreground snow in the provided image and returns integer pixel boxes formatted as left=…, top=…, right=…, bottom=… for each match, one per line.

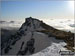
left=1, top=17, right=74, bottom=55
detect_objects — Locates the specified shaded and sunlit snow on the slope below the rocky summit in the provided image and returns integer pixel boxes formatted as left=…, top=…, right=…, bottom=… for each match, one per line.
left=1, top=32, right=66, bottom=56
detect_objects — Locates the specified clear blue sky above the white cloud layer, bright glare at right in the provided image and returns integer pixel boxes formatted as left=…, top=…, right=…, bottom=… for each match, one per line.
left=0, top=0, right=74, bottom=20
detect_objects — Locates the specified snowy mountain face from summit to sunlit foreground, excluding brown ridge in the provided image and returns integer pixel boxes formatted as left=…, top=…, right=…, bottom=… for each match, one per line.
left=2, top=17, right=69, bottom=56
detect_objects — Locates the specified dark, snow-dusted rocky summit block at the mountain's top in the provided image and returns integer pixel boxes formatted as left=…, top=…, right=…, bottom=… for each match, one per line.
left=20, top=17, right=41, bottom=31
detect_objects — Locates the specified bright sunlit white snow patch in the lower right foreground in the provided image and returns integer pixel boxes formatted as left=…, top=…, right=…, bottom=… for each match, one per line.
left=31, top=43, right=66, bottom=56
